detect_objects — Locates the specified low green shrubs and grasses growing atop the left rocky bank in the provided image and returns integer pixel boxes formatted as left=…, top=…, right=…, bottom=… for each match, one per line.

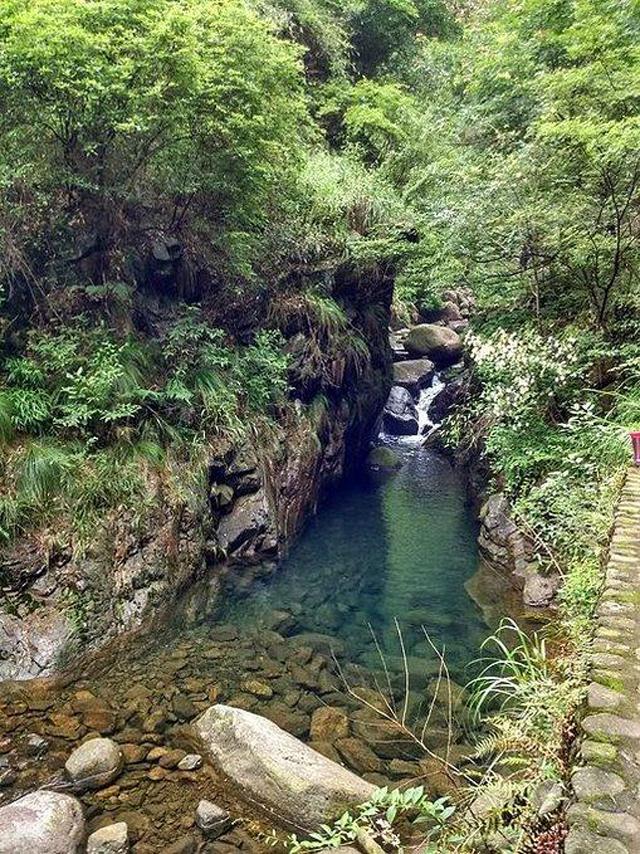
left=0, top=306, right=289, bottom=542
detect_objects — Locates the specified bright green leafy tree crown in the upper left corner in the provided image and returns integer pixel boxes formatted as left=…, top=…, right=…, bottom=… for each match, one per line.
left=0, top=0, right=306, bottom=280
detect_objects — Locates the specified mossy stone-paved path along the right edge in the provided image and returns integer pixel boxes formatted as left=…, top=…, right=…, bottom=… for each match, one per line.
left=565, top=468, right=640, bottom=854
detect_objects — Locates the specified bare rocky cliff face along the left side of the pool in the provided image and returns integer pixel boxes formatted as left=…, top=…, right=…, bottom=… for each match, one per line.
left=0, top=268, right=391, bottom=680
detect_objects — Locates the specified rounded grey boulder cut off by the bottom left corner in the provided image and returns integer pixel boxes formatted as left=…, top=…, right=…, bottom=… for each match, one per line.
left=0, top=789, right=85, bottom=854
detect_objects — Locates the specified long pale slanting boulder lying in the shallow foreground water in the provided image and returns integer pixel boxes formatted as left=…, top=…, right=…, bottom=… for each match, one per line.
left=194, top=705, right=374, bottom=829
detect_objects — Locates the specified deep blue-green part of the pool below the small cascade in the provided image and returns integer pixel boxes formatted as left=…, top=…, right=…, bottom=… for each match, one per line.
left=225, top=437, right=487, bottom=681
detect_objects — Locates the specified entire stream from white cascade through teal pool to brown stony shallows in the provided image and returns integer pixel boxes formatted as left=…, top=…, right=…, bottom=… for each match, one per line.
left=0, top=389, right=487, bottom=854
